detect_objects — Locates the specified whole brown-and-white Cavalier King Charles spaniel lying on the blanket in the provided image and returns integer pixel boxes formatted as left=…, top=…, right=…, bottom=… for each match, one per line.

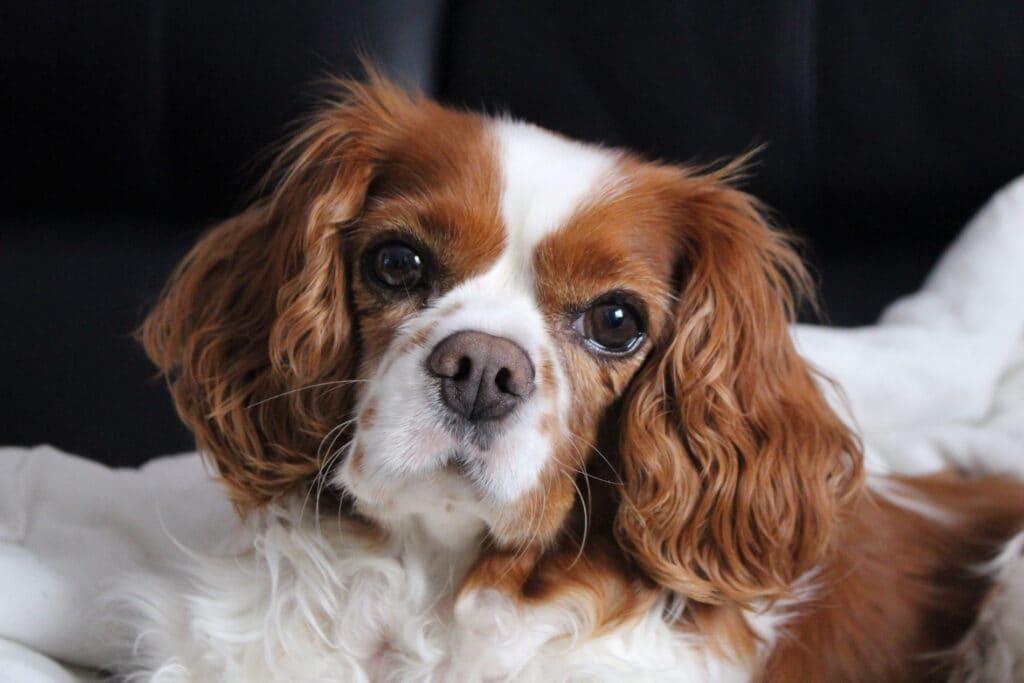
left=128, top=74, right=1024, bottom=682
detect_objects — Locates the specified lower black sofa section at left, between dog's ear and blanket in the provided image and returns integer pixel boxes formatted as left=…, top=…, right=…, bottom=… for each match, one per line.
left=0, top=219, right=199, bottom=466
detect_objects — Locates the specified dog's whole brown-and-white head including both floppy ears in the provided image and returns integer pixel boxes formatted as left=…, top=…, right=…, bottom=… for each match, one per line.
left=143, top=81, right=857, bottom=600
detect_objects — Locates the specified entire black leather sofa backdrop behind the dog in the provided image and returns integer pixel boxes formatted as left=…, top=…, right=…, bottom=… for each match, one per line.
left=0, top=0, right=1024, bottom=465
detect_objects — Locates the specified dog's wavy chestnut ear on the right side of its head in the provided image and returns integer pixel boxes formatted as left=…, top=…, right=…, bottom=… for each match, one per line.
left=615, top=168, right=861, bottom=604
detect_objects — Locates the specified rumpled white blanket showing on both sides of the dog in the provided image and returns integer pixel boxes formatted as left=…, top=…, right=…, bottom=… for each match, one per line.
left=0, top=178, right=1024, bottom=683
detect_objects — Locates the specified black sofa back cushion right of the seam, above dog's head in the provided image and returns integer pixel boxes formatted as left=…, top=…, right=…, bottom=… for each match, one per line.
left=439, top=0, right=1024, bottom=325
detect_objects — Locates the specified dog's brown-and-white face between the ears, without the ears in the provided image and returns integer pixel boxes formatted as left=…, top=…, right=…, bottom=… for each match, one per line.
left=333, top=117, right=674, bottom=543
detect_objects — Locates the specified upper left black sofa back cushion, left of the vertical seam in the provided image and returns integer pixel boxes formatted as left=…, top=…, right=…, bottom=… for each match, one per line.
left=0, top=0, right=440, bottom=217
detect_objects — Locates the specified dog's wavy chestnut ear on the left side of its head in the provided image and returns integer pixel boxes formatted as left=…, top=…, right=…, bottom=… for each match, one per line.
left=140, top=74, right=414, bottom=513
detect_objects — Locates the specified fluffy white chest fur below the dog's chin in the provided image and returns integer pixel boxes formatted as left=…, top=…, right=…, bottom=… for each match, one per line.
left=120, top=497, right=750, bottom=683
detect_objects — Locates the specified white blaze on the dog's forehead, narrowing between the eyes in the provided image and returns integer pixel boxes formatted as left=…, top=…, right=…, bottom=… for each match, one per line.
left=493, top=119, right=617, bottom=282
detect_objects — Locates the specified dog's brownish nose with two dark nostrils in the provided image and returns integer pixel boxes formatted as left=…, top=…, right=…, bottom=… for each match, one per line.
left=427, top=330, right=534, bottom=421
